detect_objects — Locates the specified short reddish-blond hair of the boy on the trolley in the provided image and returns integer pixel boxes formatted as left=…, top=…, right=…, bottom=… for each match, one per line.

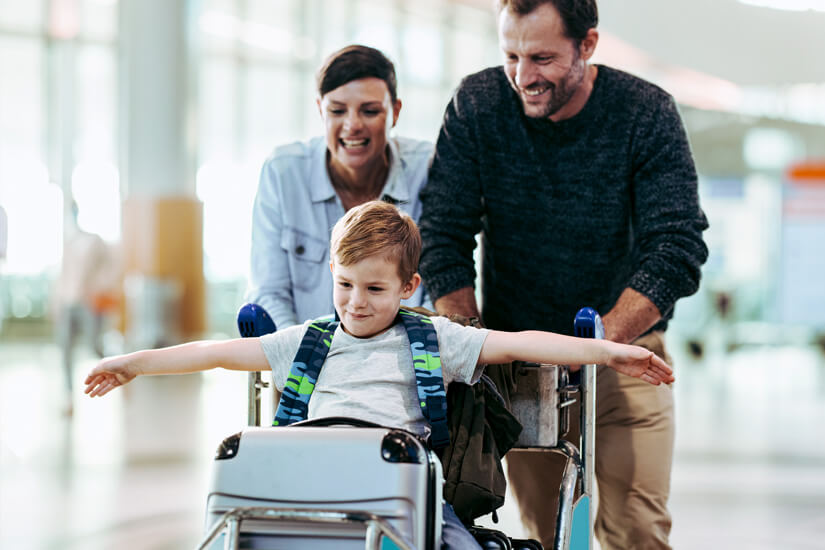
left=329, top=201, right=421, bottom=283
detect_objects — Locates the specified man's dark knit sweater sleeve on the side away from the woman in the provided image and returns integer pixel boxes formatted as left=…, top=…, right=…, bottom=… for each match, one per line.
left=628, top=95, right=708, bottom=316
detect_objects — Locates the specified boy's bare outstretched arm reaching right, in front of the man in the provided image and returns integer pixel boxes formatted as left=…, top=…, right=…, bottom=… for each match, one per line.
left=478, top=330, right=674, bottom=385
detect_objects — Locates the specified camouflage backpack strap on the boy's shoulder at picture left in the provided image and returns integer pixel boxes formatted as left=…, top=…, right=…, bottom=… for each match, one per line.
left=272, top=316, right=338, bottom=426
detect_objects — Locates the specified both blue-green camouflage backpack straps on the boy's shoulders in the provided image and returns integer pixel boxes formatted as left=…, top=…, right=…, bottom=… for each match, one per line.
left=272, top=309, right=450, bottom=451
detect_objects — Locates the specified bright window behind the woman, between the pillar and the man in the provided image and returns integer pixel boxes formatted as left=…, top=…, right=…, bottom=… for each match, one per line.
left=197, top=0, right=498, bottom=285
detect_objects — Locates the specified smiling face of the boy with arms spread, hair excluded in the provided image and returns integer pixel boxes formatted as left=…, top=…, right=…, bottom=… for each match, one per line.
left=329, top=255, right=421, bottom=338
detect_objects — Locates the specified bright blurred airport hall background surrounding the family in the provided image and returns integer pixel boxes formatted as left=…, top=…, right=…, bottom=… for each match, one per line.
left=0, top=0, right=825, bottom=549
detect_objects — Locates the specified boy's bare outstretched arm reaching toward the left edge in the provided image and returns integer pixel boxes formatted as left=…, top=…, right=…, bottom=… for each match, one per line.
left=84, top=338, right=269, bottom=397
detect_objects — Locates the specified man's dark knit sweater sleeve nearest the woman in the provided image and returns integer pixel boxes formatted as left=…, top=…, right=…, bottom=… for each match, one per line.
left=419, top=80, right=483, bottom=302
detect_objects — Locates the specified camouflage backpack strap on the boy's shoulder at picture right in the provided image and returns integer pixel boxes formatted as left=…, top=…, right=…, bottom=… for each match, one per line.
left=398, top=309, right=450, bottom=450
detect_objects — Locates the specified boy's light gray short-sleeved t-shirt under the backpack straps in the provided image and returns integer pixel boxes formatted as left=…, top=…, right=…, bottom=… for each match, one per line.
left=261, top=317, right=488, bottom=436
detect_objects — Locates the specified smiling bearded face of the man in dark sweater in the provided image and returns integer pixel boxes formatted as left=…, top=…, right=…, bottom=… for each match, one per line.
left=498, top=4, right=586, bottom=118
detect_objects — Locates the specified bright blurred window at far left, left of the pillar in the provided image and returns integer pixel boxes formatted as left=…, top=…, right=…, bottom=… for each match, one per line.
left=0, top=0, right=120, bottom=328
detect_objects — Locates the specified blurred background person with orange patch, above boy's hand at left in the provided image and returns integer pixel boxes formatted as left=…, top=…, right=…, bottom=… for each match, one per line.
left=52, top=201, right=120, bottom=415
